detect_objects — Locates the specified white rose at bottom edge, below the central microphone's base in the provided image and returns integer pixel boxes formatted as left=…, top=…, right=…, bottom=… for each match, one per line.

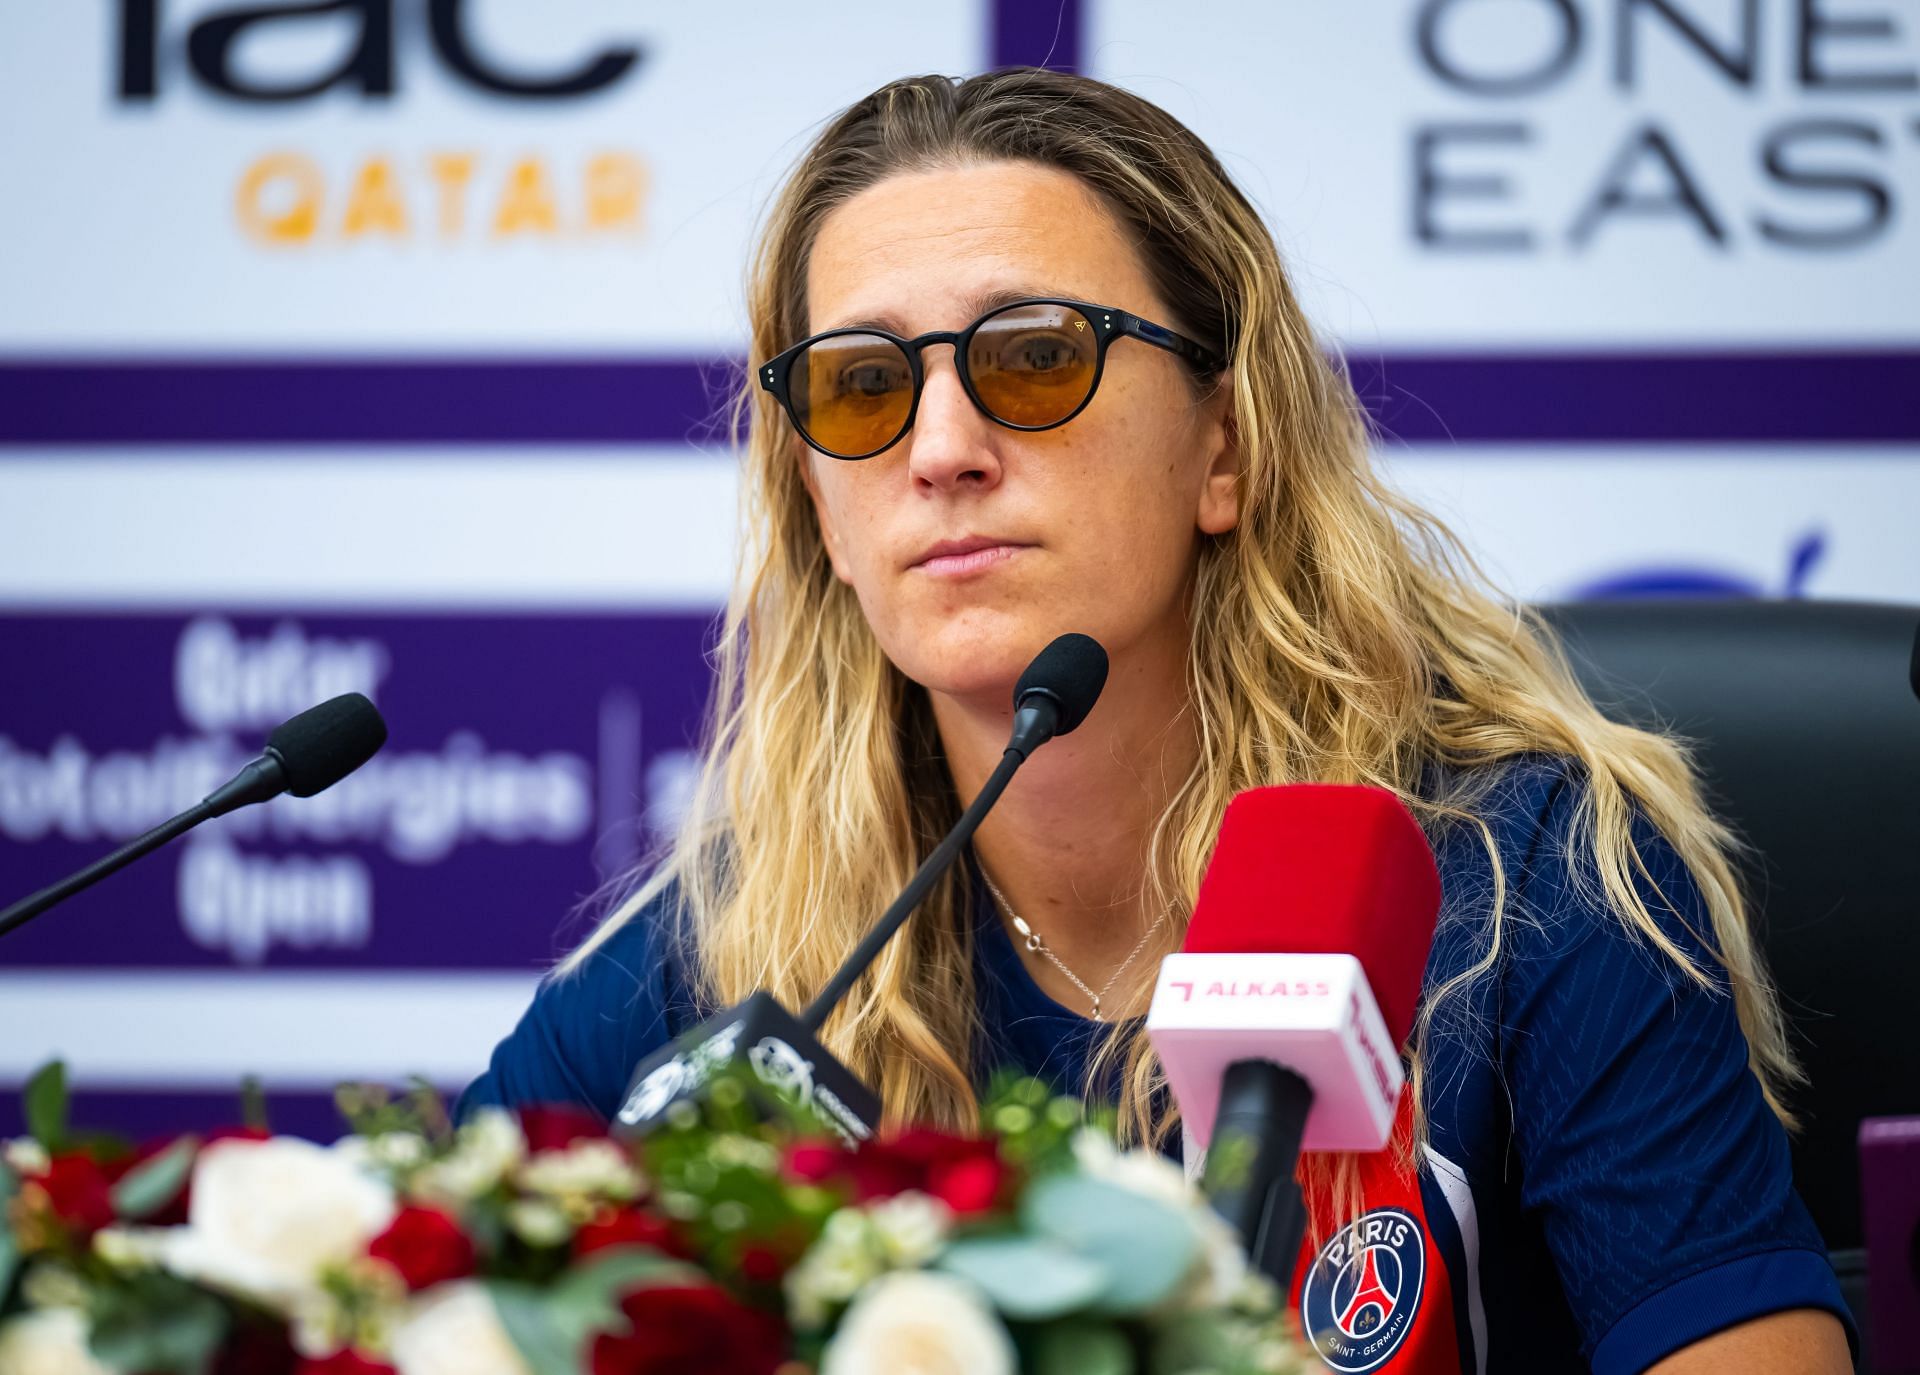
left=821, top=1269, right=1020, bottom=1375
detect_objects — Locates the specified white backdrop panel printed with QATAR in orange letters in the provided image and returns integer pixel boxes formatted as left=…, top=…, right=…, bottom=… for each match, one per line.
left=0, top=0, right=987, bottom=353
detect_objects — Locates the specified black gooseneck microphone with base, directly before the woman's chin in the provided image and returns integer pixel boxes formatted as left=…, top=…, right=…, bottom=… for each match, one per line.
left=612, top=636, right=1106, bottom=1145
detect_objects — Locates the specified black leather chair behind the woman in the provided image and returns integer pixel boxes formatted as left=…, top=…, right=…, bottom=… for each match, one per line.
left=1542, top=599, right=1920, bottom=1367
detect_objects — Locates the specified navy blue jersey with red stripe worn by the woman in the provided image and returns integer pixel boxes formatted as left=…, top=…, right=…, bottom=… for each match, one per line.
left=461, top=759, right=1851, bottom=1375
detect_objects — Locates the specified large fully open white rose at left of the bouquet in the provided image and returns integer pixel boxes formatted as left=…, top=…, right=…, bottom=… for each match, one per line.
left=161, top=1137, right=396, bottom=1312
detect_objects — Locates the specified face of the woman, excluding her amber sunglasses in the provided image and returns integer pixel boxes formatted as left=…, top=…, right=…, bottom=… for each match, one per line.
left=804, top=163, right=1238, bottom=701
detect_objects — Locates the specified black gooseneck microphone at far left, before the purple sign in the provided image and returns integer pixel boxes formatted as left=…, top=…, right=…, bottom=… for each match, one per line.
left=0, top=691, right=386, bottom=935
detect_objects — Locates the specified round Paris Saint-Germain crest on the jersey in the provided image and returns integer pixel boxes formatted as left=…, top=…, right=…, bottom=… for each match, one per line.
left=1300, top=1208, right=1427, bottom=1375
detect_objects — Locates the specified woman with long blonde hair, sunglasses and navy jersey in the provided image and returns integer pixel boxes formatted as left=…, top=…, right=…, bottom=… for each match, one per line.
left=463, top=69, right=1847, bottom=1371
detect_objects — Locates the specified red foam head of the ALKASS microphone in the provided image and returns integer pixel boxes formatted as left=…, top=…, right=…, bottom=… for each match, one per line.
left=1181, top=784, right=1440, bottom=1047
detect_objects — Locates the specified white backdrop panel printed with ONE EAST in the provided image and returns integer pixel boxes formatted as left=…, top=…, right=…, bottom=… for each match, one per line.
left=1085, top=0, right=1920, bottom=350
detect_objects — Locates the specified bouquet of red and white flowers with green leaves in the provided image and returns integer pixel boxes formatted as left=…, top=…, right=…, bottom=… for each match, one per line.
left=0, top=1064, right=1306, bottom=1375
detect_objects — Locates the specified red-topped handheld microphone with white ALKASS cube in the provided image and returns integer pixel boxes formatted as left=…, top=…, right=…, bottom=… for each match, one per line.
left=1146, top=784, right=1440, bottom=1283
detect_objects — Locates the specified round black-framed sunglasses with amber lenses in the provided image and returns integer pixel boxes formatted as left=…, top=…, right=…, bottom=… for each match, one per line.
left=760, top=298, right=1225, bottom=459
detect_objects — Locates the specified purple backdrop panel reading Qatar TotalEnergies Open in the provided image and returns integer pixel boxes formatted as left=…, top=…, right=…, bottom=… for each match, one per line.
left=0, top=615, right=707, bottom=968
